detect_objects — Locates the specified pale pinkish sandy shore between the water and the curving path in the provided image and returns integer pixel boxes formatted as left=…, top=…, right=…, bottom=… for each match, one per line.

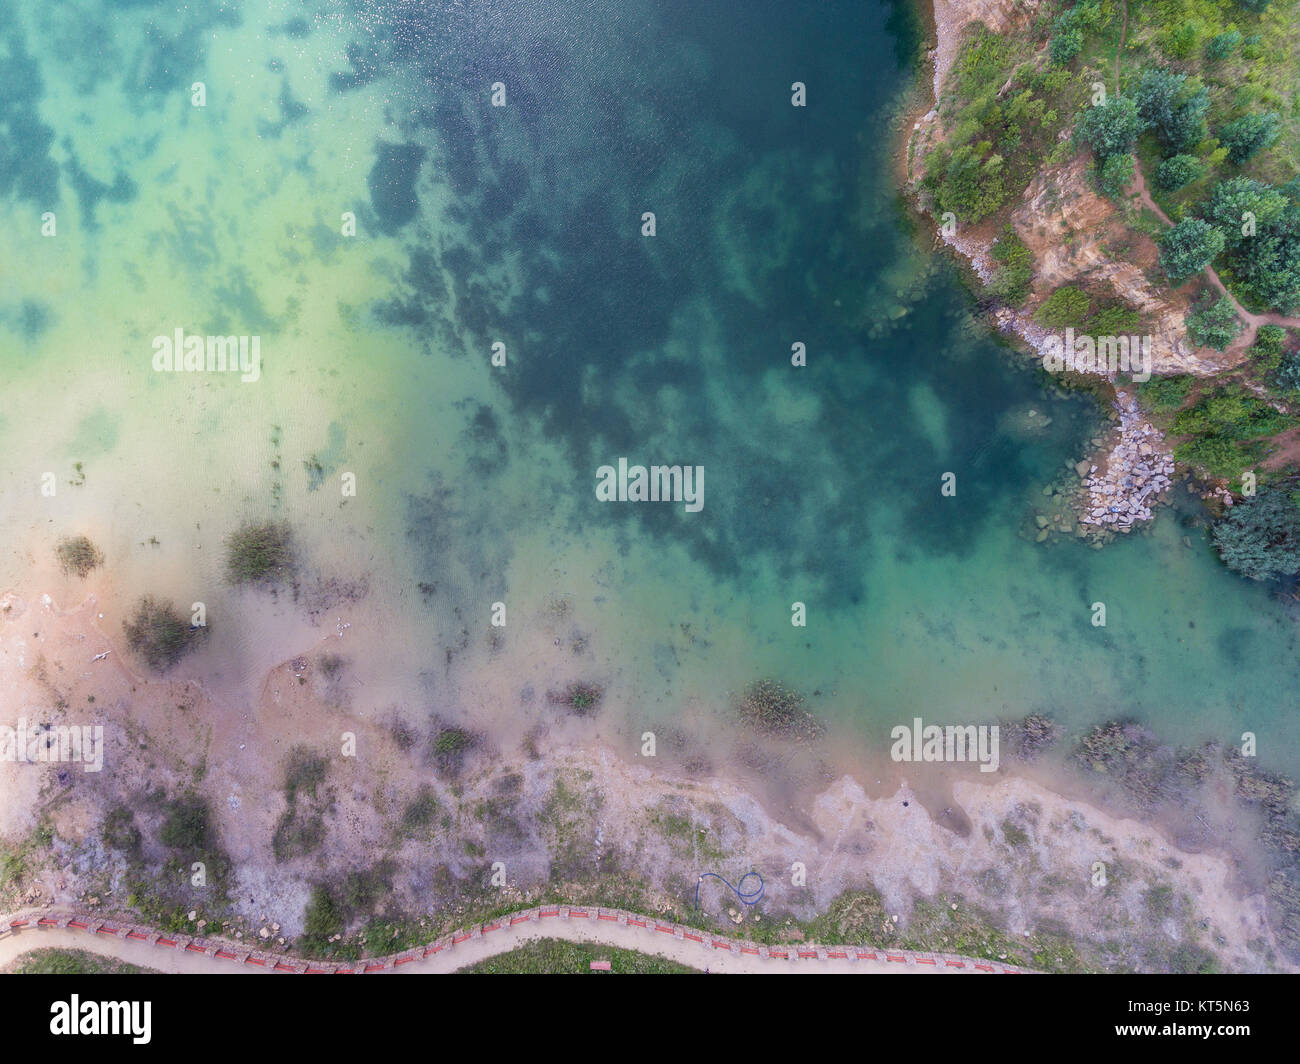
left=0, top=580, right=1278, bottom=970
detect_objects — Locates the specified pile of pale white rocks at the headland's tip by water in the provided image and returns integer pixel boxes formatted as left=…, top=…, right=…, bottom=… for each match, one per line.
left=1078, top=392, right=1174, bottom=532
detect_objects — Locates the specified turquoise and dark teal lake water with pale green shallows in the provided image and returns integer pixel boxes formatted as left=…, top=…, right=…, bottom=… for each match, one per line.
left=0, top=0, right=1300, bottom=767
